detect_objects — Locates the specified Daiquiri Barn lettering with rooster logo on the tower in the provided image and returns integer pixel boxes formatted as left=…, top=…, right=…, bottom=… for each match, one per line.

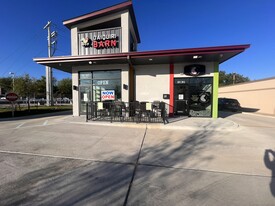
left=81, top=34, right=118, bottom=49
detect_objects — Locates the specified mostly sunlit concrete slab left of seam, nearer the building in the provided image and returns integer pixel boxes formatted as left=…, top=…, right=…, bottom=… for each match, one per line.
left=0, top=123, right=145, bottom=163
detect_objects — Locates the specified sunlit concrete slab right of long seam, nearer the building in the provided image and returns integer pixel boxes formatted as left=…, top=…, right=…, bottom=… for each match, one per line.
left=140, top=129, right=275, bottom=176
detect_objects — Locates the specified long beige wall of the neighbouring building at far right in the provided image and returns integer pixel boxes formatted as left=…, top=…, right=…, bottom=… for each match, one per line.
left=219, top=78, right=275, bottom=115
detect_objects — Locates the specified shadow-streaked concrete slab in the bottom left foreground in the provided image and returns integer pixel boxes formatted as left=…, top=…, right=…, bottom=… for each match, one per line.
left=0, top=154, right=134, bottom=206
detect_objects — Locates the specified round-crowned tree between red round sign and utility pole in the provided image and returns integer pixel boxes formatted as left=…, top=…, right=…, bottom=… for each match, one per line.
left=14, top=74, right=37, bottom=111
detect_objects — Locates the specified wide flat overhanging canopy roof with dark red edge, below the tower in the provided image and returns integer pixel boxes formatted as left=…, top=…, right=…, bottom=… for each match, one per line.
left=33, top=44, right=250, bottom=73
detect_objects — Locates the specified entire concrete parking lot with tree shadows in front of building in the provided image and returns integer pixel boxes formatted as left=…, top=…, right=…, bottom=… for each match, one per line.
left=0, top=114, right=275, bottom=205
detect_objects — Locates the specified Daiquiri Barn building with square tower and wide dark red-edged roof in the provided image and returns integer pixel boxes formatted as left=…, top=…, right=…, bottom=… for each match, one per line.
left=34, top=1, right=249, bottom=118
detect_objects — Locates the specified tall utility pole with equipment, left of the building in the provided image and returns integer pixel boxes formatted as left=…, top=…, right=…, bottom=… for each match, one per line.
left=43, top=21, right=57, bottom=106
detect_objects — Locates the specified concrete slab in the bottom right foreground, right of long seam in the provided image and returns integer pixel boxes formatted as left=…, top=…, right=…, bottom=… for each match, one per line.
left=128, top=165, right=275, bottom=206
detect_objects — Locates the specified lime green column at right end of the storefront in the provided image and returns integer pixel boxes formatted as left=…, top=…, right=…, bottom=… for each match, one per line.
left=212, top=63, right=219, bottom=118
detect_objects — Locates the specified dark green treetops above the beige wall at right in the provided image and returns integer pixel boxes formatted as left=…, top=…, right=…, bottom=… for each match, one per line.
left=219, top=71, right=250, bottom=86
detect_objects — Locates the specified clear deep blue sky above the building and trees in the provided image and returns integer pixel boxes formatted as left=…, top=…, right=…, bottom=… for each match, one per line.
left=0, top=0, right=275, bottom=80
